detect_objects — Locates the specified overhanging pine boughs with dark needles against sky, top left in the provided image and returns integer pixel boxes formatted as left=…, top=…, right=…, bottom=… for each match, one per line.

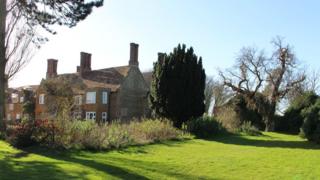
left=17, top=0, right=103, bottom=34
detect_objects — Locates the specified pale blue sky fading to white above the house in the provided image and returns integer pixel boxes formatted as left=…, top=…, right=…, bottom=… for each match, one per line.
left=9, top=0, right=320, bottom=87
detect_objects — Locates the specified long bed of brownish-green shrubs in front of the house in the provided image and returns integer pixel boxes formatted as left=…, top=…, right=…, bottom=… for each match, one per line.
left=9, top=119, right=184, bottom=150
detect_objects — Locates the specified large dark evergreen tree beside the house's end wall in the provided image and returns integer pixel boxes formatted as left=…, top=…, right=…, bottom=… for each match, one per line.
left=149, top=44, right=206, bottom=128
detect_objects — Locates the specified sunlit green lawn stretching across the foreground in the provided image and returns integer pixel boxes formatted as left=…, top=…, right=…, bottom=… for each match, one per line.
left=0, top=133, right=320, bottom=180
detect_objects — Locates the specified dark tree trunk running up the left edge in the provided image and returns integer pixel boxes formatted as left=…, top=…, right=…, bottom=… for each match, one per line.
left=0, top=0, right=7, bottom=132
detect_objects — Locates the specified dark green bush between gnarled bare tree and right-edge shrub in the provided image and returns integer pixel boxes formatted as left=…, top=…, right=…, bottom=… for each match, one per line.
left=276, top=92, right=319, bottom=134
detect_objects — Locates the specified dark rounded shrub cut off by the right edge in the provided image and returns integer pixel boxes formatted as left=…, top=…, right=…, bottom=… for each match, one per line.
left=300, top=99, right=320, bottom=144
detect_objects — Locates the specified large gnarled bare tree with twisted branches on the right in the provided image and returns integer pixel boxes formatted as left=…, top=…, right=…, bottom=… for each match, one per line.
left=220, top=37, right=305, bottom=131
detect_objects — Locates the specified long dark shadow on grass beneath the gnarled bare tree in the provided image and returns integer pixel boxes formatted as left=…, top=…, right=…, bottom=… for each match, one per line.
left=206, top=135, right=320, bottom=149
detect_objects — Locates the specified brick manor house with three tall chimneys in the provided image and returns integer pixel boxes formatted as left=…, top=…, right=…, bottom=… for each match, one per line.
left=6, top=43, right=150, bottom=122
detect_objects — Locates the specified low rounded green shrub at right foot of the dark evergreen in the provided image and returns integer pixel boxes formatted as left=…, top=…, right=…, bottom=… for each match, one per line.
left=186, top=116, right=226, bottom=138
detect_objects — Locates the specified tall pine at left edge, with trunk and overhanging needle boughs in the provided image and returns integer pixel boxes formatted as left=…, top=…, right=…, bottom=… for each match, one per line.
left=0, top=0, right=103, bottom=131
